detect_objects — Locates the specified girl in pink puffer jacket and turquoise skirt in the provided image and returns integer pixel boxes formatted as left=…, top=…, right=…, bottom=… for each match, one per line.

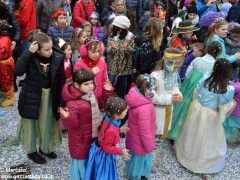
left=126, top=74, right=157, bottom=180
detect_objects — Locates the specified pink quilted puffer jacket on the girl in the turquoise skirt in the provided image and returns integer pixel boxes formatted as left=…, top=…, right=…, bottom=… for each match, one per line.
left=126, top=87, right=157, bottom=155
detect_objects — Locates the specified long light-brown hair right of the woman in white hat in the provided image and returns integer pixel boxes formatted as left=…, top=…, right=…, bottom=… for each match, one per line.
left=145, top=18, right=163, bottom=52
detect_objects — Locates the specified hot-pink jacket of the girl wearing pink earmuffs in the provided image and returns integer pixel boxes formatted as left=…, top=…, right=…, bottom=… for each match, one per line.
left=74, top=59, right=108, bottom=98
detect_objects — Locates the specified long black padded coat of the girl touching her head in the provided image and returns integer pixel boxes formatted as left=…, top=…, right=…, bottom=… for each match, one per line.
left=14, top=49, right=66, bottom=120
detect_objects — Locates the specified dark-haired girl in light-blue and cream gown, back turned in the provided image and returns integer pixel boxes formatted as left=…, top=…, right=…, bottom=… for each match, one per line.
left=175, top=59, right=234, bottom=174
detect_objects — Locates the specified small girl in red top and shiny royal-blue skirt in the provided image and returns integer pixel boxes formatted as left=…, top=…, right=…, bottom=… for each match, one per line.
left=85, top=97, right=131, bottom=180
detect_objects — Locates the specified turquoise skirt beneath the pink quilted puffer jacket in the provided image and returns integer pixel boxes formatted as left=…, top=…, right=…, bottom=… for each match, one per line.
left=126, top=151, right=153, bottom=180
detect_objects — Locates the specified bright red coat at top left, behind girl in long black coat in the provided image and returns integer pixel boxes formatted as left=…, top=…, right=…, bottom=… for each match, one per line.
left=14, top=0, right=36, bottom=41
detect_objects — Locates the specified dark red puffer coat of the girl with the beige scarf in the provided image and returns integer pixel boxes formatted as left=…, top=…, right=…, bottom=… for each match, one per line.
left=61, top=82, right=113, bottom=160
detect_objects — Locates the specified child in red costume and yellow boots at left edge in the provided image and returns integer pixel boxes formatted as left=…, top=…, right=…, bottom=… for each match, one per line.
left=0, top=20, right=15, bottom=107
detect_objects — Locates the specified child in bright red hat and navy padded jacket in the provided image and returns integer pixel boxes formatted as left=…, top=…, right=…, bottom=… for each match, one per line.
left=48, top=8, right=74, bottom=46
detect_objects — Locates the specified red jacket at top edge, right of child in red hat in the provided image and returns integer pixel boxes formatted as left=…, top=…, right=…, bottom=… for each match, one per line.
left=72, top=1, right=95, bottom=28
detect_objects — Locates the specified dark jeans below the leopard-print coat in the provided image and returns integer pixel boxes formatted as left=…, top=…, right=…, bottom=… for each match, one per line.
left=108, top=74, right=128, bottom=99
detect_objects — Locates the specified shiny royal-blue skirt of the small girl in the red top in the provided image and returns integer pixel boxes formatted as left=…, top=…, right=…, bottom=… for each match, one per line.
left=85, top=142, right=118, bottom=180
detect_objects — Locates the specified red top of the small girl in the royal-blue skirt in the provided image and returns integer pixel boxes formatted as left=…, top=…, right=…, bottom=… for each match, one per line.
left=98, top=119, right=122, bottom=155
